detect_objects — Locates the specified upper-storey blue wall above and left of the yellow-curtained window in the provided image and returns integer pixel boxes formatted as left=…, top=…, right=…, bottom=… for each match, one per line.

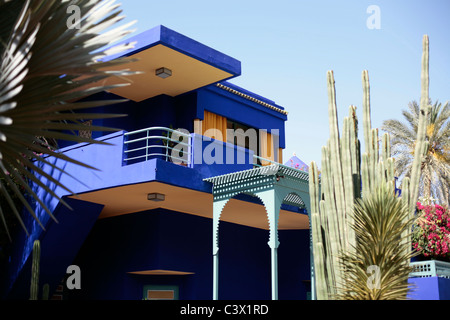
left=63, top=80, right=287, bottom=148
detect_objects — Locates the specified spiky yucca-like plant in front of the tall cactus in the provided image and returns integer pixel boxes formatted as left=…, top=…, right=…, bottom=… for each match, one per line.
left=337, top=184, right=415, bottom=300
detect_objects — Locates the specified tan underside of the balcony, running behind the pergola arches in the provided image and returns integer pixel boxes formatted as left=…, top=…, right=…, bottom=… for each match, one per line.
left=72, top=181, right=309, bottom=230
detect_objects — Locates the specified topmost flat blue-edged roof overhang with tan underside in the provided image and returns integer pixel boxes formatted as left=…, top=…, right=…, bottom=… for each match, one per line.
left=90, top=26, right=241, bottom=102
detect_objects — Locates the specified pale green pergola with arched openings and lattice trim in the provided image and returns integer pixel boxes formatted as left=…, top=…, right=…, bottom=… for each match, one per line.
left=204, top=164, right=314, bottom=300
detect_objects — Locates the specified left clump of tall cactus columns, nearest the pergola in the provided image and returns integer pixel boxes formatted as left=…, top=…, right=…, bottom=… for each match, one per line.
left=310, top=71, right=361, bottom=299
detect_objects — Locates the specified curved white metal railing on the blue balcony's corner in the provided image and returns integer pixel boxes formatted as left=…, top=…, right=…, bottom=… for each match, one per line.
left=124, top=127, right=192, bottom=164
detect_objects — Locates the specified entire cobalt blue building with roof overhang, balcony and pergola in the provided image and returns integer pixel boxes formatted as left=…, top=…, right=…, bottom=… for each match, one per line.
left=1, top=26, right=311, bottom=300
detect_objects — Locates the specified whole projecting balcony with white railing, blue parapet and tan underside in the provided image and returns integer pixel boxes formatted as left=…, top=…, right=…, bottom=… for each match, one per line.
left=24, top=127, right=308, bottom=234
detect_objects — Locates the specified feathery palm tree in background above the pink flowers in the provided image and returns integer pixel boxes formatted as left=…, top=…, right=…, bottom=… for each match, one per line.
left=382, top=101, right=450, bottom=204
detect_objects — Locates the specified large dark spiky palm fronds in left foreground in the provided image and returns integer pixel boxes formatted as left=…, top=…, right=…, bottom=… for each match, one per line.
left=0, top=0, right=137, bottom=239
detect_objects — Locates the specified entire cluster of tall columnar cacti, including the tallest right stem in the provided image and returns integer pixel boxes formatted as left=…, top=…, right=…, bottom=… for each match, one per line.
left=309, top=36, right=429, bottom=299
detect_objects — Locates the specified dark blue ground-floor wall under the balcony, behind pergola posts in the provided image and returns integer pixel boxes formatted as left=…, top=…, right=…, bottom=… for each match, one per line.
left=69, top=209, right=310, bottom=300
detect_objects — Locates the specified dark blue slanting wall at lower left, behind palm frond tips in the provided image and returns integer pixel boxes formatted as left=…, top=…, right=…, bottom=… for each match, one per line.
left=0, top=199, right=103, bottom=300
